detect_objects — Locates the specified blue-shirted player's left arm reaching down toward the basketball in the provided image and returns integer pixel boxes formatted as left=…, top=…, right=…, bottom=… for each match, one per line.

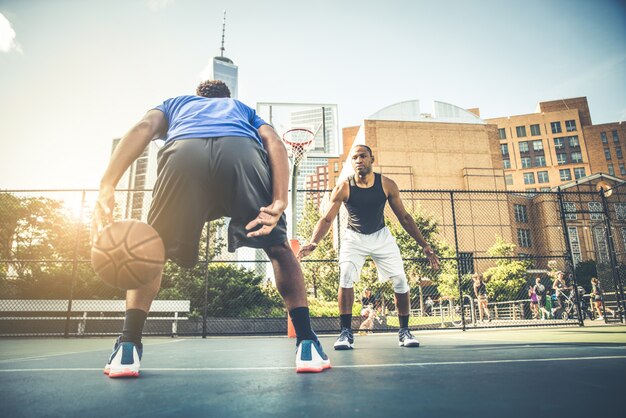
left=91, top=109, right=167, bottom=243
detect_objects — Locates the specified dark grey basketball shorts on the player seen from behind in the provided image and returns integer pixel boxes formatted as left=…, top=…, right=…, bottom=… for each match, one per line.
left=148, top=137, right=287, bottom=267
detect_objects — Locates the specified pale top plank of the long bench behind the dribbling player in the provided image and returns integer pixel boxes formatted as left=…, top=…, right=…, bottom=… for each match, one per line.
left=0, top=299, right=190, bottom=312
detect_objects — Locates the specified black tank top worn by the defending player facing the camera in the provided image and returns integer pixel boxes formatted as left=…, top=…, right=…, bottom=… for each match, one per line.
left=345, top=173, right=387, bottom=234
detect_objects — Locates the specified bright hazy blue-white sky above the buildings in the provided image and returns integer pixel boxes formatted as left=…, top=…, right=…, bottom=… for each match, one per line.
left=0, top=0, right=626, bottom=190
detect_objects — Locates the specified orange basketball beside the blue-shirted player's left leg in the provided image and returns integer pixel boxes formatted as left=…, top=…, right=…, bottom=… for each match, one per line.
left=91, top=219, right=165, bottom=290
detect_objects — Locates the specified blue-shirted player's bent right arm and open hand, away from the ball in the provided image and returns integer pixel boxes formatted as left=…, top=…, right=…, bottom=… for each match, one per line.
left=246, top=125, right=289, bottom=237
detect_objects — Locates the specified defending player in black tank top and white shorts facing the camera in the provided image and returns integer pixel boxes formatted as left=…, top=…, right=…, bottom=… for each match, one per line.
left=298, top=145, right=439, bottom=350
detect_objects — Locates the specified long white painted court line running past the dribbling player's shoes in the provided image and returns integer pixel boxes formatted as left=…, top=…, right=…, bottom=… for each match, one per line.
left=0, top=356, right=626, bottom=373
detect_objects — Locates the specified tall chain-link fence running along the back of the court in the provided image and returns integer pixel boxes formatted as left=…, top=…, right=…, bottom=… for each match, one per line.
left=0, top=188, right=626, bottom=336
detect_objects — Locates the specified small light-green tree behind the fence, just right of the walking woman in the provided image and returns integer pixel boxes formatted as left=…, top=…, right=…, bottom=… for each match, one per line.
left=484, top=237, right=529, bottom=302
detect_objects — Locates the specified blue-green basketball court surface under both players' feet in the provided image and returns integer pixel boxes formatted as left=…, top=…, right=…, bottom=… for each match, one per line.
left=0, top=326, right=626, bottom=418
